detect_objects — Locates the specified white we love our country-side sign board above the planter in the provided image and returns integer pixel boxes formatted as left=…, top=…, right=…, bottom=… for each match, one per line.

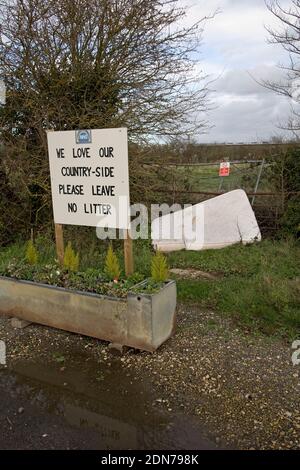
left=47, top=128, right=130, bottom=229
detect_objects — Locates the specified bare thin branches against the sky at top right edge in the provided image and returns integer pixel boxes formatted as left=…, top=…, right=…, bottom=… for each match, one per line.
left=262, top=0, right=300, bottom=137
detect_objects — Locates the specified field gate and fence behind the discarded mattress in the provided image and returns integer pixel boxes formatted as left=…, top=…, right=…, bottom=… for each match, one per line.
left=143, top=159, right=300, bottom=234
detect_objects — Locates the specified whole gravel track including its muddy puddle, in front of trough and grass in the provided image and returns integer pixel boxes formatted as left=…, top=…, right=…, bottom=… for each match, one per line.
left=0, top=306, right=300, bottom=449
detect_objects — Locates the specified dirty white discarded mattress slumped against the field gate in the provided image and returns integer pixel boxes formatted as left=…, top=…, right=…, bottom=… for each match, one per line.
left=151, top=189, right=261, bottom=251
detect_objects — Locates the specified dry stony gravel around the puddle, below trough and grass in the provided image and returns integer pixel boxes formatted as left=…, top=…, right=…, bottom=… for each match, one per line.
left=0, top=305, right=300, bottom=449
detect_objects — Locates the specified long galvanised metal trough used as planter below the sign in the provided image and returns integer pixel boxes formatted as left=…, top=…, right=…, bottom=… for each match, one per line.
left=0, top=276, right=176, bottom=352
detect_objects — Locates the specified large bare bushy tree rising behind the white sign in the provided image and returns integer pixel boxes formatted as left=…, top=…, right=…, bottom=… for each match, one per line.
left=0, top=0, right=208, bottom=235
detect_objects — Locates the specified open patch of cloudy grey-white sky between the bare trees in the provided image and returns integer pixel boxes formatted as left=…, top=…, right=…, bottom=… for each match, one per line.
left=181, top=0, right=290, bottom=142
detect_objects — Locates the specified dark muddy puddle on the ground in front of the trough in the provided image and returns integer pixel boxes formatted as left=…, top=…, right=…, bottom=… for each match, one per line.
left=0, top=353, right=214, bottom=450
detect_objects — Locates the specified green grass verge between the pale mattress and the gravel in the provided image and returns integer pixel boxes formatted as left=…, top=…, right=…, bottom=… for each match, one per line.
left=169, top=240, right=300, bottom=337
